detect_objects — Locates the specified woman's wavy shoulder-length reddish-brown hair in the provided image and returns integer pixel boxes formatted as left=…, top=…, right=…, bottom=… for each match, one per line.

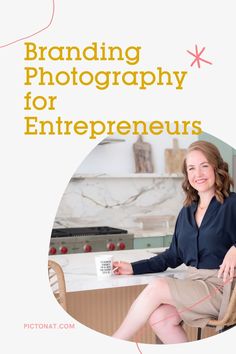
left=182, top=140, right=233, bottom=206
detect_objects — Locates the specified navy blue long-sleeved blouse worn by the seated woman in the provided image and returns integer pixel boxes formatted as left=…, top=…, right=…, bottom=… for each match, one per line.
left=131, top=192, right=236, bottom=274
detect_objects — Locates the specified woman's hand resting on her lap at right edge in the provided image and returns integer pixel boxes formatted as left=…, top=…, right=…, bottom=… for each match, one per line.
left=218, top=246, right=236, bottom=283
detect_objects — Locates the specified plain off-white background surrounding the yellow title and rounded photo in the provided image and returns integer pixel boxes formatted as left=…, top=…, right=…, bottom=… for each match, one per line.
left=0, top=0, right=236, bottom=354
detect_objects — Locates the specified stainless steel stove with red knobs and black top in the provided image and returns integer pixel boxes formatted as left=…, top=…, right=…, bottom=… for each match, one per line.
left=49, top=226, right=134, bottom=255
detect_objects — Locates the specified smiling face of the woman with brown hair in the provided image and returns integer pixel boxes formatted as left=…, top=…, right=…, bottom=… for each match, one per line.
left=186, top=150, right=215, bottom=194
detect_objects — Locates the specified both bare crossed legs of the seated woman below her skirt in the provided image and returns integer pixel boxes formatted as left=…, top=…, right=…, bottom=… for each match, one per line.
left=113, top=278, right=187, bottom=343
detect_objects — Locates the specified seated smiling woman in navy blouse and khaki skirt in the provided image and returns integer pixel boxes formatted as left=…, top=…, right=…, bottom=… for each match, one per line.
left=113, top=141, right=236, bottom=343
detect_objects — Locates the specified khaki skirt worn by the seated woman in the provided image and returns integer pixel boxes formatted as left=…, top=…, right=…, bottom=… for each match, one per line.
left=166, top=267, right=234, bottom=327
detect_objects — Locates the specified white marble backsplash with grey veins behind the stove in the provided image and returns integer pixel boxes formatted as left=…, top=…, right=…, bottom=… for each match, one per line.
left=54, top=174, right=183, bottom=236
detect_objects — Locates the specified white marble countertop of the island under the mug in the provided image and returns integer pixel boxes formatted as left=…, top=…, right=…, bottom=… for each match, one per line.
left=49, top=248, right=185, bottom=292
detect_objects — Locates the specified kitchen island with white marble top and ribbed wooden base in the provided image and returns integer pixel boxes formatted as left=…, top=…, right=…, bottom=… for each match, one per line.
left=49, top=248, right=215, bottom=343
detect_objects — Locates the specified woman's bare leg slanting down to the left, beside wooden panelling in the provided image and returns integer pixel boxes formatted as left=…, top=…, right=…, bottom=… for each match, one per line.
left=113, top=278, right=177, bottom=340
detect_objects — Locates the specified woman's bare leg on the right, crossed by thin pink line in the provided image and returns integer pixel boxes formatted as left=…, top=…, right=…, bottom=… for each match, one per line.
left=149, top=305, right=188, bottom=344
